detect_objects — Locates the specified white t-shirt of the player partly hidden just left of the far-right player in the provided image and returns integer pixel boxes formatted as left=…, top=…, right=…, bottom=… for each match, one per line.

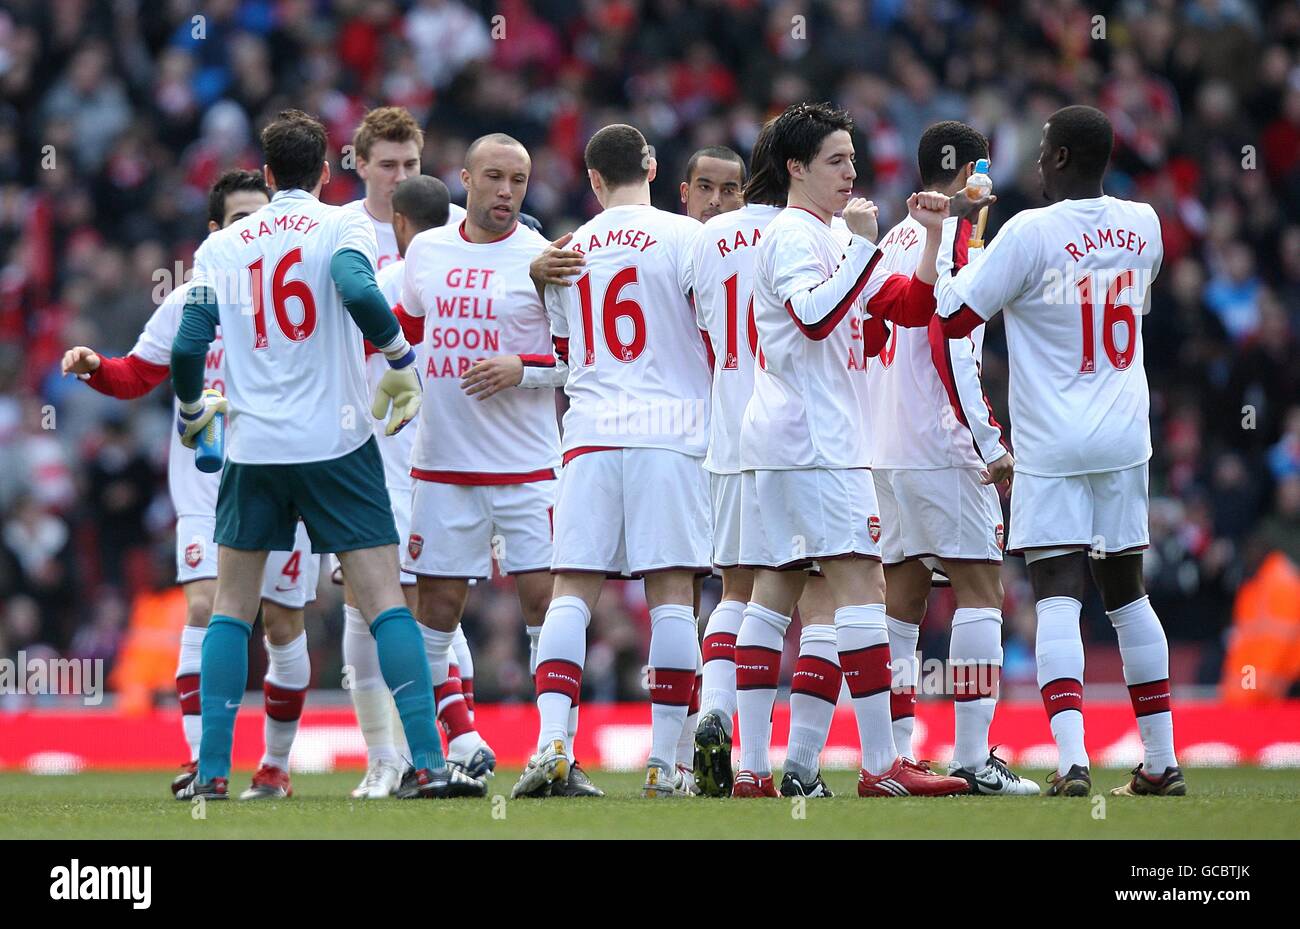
left=867, top=216, right=1006, bottom=470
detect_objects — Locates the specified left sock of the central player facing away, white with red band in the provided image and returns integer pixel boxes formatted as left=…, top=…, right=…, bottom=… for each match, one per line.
left=533, top=596, right=592, bottom=751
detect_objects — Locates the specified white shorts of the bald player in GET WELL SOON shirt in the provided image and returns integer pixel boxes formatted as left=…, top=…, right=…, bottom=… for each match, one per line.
left=402, top=481, right=555, bottom=578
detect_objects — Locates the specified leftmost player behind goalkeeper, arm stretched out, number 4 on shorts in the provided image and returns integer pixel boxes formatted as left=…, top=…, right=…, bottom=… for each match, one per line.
left=62, top=170, right=320, bottom=800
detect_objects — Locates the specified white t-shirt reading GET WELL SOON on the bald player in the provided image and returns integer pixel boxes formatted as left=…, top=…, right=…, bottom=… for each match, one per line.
left=402, top=223, right=559, bottom=482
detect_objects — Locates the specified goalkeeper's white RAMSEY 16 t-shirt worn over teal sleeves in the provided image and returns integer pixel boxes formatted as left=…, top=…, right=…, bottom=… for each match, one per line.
left=189, top=190, right=376, bottom=464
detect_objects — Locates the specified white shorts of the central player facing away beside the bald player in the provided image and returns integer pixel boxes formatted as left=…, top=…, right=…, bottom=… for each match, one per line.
left=551, top=448, right=712, bottom=577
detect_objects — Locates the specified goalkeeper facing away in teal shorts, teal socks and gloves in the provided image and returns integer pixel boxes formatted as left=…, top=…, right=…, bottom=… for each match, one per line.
left=172, top=110, right=486, bottom=799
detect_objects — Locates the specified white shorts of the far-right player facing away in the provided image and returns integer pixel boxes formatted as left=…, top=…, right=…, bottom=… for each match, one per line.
left=1008, top=464, right=1149, bottom=555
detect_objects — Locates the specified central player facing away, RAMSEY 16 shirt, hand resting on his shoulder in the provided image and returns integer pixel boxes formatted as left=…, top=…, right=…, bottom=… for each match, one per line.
left=512, top=125, right=710, bottom=796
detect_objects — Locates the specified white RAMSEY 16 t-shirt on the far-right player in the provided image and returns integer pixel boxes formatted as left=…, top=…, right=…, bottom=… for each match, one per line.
left=935, top=196, right=1164, bottom=477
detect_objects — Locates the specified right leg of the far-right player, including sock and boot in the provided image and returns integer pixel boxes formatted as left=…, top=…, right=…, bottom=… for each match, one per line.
left=1089, top=551, right=1187, bottom=796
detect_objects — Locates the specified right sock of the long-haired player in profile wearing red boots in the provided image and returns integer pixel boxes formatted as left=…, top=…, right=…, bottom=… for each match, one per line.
left=835, top=603, right=898, bottom=774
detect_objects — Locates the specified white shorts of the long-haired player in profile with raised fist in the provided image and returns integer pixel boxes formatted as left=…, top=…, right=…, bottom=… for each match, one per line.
left=741, top=468, right=880, bottom=568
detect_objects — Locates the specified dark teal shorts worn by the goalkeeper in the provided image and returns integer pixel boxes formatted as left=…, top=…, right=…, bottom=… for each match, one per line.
left=216, top=435, right=398, bottom=554
